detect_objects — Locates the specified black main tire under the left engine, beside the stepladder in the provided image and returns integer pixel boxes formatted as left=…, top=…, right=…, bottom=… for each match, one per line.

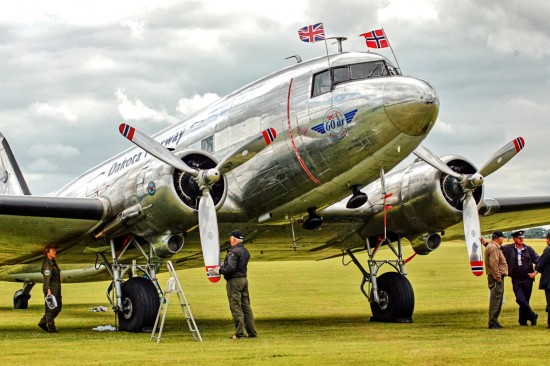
left=118, top=277, right=160, bottom=333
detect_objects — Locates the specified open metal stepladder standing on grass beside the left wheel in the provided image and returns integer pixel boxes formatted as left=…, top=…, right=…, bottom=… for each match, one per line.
left=150, top=261, right=202, bottom=343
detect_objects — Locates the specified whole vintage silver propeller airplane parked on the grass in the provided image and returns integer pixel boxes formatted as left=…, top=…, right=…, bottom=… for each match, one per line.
left=0, top=47, right=550, bottom=332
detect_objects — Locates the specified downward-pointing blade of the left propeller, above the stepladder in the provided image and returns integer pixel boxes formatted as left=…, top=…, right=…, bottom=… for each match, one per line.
left=199, top=188, right=220, bottom=282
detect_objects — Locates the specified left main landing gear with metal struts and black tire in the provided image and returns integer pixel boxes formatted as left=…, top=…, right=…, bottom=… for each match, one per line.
left=100, top=236, right=162, bottom=332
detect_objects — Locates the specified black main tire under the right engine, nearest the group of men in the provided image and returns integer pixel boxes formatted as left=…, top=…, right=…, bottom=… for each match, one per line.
left=370, top=272, right=414, bottom=323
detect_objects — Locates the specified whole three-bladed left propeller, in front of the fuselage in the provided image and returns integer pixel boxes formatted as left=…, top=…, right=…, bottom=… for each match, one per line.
left=119, top=123, right=277, bottom=282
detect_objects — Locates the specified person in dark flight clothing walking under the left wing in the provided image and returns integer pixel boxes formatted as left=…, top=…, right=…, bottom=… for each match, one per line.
left=38, top=245, right=62, bottom=333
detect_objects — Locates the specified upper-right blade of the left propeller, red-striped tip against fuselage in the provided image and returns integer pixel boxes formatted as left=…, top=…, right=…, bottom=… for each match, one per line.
left=216, top=128, right=277, bottom=175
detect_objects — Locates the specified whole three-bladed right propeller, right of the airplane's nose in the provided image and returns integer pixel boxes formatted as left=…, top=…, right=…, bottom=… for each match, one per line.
left=413, top=137, right=525, bottom=276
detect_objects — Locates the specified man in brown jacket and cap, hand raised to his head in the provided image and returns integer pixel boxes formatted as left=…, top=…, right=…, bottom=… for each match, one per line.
left=480, top=230, right=508, bottom=329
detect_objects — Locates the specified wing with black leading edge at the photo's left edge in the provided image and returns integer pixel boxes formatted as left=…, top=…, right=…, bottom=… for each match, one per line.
left=0, top=195, right=108, bottom=265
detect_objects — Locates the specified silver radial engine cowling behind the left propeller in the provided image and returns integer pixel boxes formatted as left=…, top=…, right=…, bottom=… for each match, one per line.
left=112, top=150, right=227, bottom=239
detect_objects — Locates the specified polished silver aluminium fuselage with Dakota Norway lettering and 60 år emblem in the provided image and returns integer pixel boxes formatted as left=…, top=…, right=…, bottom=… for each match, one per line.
left=54, top=53, right=439, bottom=224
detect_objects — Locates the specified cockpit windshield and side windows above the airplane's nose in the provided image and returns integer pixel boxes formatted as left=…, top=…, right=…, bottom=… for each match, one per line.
left=311, top=61, right=401, bottom=97
